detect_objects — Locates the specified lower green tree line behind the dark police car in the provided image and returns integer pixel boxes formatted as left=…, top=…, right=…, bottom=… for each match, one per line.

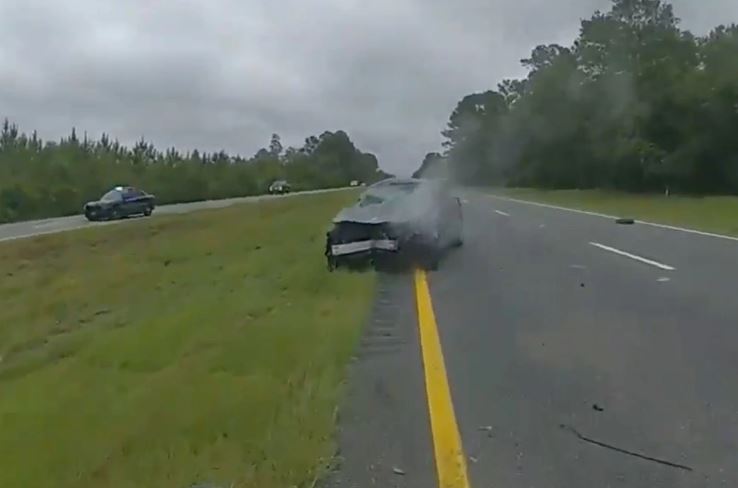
left=0, top=120, right=387, bottom=222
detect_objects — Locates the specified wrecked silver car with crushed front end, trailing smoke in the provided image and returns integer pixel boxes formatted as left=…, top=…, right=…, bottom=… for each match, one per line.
left=325, top=178, right=463, bottom=270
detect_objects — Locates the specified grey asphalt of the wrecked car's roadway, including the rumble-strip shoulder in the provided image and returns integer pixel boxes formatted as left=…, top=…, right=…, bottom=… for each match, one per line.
left=327, top=193, right=738, bottom=488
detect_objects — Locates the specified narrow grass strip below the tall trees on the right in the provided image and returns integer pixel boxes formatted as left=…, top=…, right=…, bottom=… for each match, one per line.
left=494, top=189, right=738, bottom=235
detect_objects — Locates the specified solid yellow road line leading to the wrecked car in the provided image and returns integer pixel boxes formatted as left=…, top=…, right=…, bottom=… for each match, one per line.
left=415, top=270, right=469, bottom=488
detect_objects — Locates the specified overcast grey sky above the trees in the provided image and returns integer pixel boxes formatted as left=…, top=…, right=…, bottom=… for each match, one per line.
left=0, top=0, right=738, bottom=174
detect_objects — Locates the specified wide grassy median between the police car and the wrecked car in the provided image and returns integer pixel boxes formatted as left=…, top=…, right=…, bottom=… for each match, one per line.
left=0, top=192, right=374, bottom=488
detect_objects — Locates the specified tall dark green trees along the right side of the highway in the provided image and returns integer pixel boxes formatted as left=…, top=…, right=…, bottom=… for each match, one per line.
left=426, top=0, right=738, bottom=194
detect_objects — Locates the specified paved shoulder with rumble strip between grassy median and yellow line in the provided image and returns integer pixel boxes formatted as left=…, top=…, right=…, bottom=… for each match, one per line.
left=322, top=275, right=437, bottom=488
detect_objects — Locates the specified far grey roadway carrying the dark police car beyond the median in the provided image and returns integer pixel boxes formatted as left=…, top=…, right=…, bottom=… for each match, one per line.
left=0, top=188, right=347, bottom=246
